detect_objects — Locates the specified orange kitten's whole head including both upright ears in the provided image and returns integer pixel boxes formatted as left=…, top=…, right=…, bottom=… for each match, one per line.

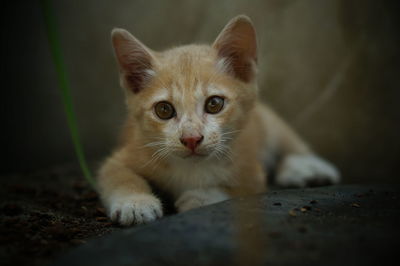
left=112, top=16, right=257, bottom=159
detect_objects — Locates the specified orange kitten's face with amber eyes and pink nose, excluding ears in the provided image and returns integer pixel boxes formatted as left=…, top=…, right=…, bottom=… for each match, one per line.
left=128, top=46, right=255, bottom=159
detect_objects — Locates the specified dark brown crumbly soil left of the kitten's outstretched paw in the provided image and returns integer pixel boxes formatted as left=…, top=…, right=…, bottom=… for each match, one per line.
left=0, top=165, right=121, bottom=265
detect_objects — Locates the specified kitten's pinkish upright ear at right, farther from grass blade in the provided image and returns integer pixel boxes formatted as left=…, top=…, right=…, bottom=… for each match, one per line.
left=213, top=15, right=257, bottom=82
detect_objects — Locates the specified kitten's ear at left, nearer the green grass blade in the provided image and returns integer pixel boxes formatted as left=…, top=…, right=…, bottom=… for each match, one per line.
left=111, top=29, right=154, bottom=93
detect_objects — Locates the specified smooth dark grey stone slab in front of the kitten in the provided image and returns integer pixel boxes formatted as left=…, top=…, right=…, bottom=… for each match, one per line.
left=54, top=186, right=400, bottom=266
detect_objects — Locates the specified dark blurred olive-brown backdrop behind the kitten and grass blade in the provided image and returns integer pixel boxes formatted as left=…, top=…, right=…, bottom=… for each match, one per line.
left=1, top=0, right=400, bottom=183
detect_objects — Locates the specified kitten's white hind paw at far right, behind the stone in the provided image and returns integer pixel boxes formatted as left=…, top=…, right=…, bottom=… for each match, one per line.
left=276, top=155, right=340, bottom=187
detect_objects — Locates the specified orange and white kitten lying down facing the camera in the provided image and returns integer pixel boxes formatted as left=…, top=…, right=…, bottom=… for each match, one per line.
left=98, top=15, right=339, bottom=225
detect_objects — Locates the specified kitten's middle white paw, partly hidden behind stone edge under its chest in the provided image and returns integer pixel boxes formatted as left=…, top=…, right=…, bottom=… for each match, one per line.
left=175, top=188, right=229, bottom=212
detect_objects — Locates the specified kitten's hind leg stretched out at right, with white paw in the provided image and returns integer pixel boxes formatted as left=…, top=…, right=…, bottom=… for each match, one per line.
left=267, top=106, right=340, bottom=187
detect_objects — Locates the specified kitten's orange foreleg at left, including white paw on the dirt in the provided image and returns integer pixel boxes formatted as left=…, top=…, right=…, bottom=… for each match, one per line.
left=98, top=155, right=162, bottom=225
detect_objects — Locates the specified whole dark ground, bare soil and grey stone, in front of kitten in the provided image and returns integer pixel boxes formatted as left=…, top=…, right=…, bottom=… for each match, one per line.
left=0, top=166, right=400, bottom=266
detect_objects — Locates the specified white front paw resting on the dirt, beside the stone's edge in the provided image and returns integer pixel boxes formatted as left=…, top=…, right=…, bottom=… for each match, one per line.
left=109, top=194, right=162, bottom=226
